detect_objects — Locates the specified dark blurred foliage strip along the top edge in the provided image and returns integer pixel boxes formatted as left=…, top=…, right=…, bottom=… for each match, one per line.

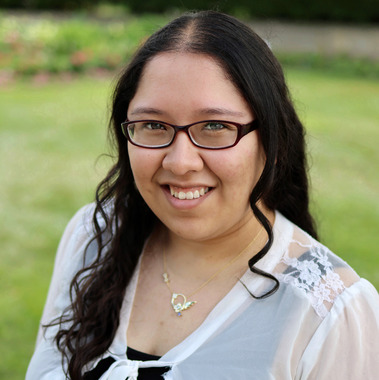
left=0, top=0, right=379, bottom=23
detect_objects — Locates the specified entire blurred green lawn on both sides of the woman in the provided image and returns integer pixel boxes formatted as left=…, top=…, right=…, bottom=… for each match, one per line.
left=0, top=70, right=379, bottom=380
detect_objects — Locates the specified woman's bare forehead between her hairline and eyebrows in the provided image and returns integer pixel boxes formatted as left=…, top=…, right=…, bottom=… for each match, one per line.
left=128, top=52, right=252, bottom=119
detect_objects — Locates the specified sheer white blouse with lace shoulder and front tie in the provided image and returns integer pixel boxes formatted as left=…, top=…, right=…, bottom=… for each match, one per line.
left=26, top=205, right=379, bottom=380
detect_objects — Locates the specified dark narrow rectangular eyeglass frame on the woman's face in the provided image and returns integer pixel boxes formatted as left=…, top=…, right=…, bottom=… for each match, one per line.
left=121, top=119, right=259, bottom=150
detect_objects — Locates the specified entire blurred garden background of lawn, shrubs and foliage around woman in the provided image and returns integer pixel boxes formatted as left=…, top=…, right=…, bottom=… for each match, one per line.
left=0, top=0, right=379, bottom=380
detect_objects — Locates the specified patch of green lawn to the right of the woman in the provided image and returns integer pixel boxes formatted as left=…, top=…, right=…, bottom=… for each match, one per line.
left=288, top=71, right=379, bottom=289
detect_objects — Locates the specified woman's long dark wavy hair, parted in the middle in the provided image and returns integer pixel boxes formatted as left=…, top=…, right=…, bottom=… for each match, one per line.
left=50, top=11, right=316, bottom=380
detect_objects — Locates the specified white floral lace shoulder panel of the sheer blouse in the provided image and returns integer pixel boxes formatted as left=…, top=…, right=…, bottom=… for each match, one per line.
left=276, top=217, right=372, bottom=318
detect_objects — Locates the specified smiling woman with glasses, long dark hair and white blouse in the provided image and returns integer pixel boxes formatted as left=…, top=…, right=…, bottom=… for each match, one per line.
left=27, top=12, right=379, bottom=380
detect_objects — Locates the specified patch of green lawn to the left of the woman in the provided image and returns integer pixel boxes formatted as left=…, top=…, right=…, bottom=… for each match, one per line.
left=0, top=78, right=110, bottom=379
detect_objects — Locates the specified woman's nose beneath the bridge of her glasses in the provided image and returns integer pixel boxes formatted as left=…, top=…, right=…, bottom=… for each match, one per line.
left=162, top=132, right=204, bottom=175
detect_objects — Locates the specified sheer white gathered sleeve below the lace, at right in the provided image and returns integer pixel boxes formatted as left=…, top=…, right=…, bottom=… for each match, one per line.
left=296, top=279, right=379, bottom=380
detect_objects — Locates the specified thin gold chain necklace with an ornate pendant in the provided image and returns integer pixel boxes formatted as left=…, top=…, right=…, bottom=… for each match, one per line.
left=163, top=227, right=263, bottom=317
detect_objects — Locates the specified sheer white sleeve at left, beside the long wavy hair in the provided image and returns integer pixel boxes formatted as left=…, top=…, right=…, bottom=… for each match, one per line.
left=26, top=206, right=93, bottom=380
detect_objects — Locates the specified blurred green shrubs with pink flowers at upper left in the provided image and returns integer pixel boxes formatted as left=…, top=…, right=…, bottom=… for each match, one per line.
left=0, top=16, right=166, bottom=75
